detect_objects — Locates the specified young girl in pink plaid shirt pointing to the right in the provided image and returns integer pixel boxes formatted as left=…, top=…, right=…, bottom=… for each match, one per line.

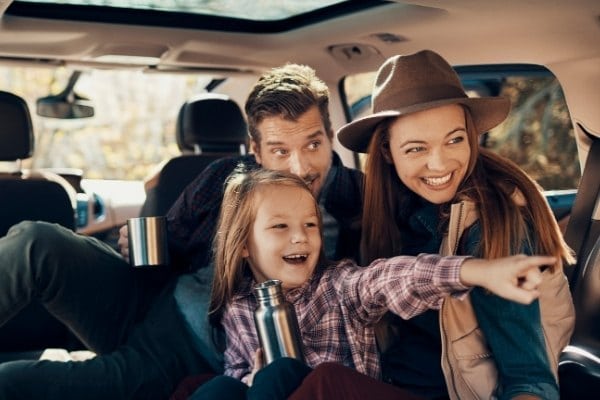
left=192, top=170, right=556, bottom=399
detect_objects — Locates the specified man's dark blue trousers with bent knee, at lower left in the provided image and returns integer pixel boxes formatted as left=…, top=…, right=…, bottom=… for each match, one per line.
left=0, top=222, right=207, bottom=400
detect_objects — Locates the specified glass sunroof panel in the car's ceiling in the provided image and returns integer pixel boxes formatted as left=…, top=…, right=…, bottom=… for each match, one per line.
left=8, top=0, right=393, bottom=33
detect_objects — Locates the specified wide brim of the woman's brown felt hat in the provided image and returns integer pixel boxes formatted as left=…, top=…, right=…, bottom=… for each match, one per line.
left=337, top=97, right=510, bottom=153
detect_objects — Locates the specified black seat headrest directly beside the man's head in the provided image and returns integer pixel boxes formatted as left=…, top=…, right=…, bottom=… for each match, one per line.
left=176, top=93, right=248, bottom=152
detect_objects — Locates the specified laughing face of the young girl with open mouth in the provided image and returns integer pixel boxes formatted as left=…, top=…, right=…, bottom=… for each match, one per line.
left=242, top=186, right=321, bottom=289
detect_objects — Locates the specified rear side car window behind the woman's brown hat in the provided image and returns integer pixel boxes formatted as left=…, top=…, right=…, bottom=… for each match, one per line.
left=342, top=65, right=581, bottom=190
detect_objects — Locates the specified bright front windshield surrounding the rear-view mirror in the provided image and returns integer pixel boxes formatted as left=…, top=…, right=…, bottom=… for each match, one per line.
left=0, top=66, right=212, bottom=180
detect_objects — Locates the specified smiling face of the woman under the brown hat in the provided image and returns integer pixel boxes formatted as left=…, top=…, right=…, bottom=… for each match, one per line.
left=389, top=104, right=471, bottom=204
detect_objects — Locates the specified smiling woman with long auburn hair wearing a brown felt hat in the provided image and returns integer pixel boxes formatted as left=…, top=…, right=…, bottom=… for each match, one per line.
left=294, top=50, right=574, bottom=399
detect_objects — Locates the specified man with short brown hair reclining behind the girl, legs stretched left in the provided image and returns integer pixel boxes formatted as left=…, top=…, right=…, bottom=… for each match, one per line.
left=0, top=65, right=362, bottom=399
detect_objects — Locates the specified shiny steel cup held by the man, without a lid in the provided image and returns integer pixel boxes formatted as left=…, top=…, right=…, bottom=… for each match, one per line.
left=127, top=217, right=169, bottom=267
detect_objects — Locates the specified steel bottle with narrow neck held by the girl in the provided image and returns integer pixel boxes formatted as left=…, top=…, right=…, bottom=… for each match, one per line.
left=254, top=280, right=304, bottom=365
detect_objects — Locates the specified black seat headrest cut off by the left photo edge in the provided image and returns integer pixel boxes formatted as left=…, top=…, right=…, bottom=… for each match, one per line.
left=0, top=91, right=33, bottom=161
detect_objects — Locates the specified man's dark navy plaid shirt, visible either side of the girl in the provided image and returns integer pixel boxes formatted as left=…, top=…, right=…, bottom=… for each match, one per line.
left=167, top=153, right=363, bottom=272
